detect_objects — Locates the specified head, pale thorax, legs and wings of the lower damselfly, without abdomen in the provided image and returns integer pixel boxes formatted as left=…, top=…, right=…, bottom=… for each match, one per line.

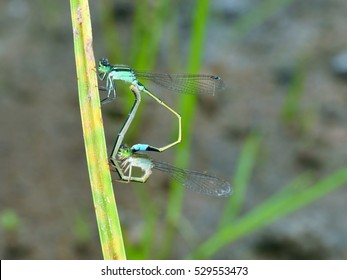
left=116, top=145, right=232, bottom=196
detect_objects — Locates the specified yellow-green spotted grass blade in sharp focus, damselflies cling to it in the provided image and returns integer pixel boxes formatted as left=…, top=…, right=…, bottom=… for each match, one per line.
left=70, top=0, right=126, bottom=260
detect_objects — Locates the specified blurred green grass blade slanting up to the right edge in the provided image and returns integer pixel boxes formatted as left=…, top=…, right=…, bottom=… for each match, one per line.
left=188, top=167, right=347, bottom=259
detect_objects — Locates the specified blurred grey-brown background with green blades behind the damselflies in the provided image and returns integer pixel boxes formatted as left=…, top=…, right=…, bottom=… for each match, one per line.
left=0, top=0, right=347, bottom=259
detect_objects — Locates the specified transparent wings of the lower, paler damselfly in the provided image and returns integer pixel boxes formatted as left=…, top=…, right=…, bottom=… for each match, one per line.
left=152, top=160, right=232, bottom=196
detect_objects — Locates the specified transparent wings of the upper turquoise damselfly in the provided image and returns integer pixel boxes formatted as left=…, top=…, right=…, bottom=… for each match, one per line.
left=134, top=70, right=224, bottom=95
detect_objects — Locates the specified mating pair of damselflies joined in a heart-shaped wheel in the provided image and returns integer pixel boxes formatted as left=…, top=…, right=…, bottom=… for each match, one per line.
left=98, top=58, right=232, bottom=196
